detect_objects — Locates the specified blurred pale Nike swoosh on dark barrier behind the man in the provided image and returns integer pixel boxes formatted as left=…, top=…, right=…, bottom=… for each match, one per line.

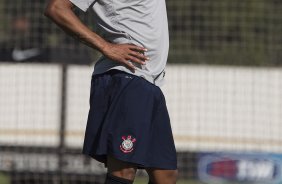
left=12, top=48, right=40, bottom=61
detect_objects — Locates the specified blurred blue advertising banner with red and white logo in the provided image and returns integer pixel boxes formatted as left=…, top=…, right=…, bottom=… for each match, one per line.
left=198, top=153, right=282, bottom=184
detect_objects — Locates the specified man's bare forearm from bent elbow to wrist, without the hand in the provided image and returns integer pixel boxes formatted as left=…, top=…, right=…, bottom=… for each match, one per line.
left=45, top=1, right=107, bottom=52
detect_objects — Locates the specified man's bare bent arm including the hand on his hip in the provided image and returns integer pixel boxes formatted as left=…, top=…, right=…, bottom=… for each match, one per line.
left=44, top=0, right=149, bottom=71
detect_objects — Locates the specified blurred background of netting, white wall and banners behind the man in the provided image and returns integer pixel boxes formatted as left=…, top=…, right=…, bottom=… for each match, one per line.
left=0, top=0, right=282, bottom=184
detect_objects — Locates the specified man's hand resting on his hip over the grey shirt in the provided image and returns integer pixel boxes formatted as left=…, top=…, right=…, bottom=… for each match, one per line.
left=102, top=42, right=149, bottom=72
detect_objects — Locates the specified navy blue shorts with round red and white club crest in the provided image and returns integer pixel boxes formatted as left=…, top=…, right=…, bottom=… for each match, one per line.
left=83, top=70, right=177, bottom=169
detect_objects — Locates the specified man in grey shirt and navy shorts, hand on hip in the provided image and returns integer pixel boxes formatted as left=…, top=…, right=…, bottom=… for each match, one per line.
left=45, top=0, right=177, bottom=184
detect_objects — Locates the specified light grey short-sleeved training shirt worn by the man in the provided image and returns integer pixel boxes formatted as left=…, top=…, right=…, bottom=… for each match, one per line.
left=70, top=0, right=169, bottom=85
